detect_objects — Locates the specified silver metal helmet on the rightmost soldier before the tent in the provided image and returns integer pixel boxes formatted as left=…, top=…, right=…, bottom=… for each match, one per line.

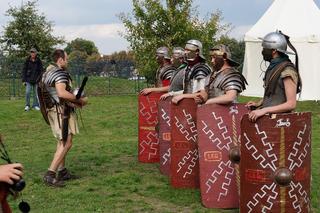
left=262, top=31, right=294, bottom=55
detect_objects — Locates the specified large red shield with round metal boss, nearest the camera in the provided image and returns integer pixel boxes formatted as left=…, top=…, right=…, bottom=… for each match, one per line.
left=240, top=112, right=311, bottom=213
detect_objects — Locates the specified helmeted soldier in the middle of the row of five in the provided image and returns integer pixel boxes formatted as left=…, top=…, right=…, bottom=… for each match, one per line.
left=172, top=39, right=211, bottom=104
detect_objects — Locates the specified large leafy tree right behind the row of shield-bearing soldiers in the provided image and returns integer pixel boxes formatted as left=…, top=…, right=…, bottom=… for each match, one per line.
left=119, top=0, right=229, bottom=81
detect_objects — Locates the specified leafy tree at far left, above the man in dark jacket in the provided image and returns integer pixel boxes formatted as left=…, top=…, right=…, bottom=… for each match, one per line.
left=0, top=0, right=64, bottom=62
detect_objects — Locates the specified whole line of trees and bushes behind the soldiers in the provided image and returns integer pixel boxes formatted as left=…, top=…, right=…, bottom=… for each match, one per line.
left=0, top=0, right=244, bottom=81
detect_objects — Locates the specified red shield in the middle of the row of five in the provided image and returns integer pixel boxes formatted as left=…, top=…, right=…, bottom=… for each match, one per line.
left=170, top=99, right=199, bottom=188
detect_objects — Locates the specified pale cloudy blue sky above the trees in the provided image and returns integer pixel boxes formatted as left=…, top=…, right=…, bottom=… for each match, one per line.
left=0, top=0, right=320, bottom=54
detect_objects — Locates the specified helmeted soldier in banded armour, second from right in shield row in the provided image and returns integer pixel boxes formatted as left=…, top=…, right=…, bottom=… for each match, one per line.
left=195, top=44, right=247, bottom=104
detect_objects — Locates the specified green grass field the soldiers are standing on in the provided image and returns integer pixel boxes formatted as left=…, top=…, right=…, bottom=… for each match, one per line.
left=0, top=96, right=320, bottom=213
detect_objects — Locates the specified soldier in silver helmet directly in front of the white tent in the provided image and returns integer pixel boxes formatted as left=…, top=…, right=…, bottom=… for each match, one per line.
left=247, top=32, right=301, bottom=122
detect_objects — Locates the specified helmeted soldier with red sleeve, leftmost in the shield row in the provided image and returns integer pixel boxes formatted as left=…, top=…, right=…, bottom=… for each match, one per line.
left=141, top=47, right=176, bottom=95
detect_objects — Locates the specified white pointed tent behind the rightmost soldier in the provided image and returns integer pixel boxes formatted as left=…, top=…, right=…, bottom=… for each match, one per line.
left=243, top=0, right=320, bottom=100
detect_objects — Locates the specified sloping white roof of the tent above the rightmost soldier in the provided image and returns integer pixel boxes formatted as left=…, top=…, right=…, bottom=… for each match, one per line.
left=245, top=0, right=320, bottom=42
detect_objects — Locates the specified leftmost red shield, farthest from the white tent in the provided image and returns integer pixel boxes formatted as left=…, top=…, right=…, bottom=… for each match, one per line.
left=138, top=93, right=163, bottom=163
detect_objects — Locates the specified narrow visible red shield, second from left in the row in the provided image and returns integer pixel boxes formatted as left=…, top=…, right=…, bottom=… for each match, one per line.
left=158, top=97, right=172, bottom=176
